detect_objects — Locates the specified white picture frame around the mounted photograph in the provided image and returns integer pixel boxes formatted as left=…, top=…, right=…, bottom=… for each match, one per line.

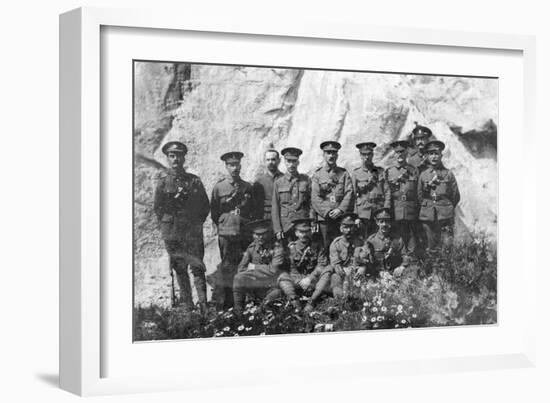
left=60, top=8, right=537, bottom=395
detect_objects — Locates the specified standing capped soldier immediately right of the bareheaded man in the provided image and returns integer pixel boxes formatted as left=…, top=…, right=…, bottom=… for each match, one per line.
left=272, top=147, right=312, bottom=240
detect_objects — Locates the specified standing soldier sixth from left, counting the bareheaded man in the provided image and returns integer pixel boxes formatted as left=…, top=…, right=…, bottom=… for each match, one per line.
left=351, top=142, right=391, bottom=239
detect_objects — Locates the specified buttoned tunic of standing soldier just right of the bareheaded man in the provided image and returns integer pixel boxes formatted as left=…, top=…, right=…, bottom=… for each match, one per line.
left=272, top=173, right=312, bottom=233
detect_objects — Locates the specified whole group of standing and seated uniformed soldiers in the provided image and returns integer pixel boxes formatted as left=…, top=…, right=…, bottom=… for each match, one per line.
left=154, top=125, right=460, bottom=312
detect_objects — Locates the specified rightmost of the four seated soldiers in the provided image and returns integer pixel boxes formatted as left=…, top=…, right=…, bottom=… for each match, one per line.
left=355, top=208, right=410, bottom=276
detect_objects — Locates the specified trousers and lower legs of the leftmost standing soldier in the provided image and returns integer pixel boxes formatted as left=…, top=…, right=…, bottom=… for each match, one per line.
left=164, top=240, right=206, bottom=307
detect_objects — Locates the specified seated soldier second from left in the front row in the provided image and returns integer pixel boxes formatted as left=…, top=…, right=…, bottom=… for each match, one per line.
left=278, top=218, right=331, bottom=312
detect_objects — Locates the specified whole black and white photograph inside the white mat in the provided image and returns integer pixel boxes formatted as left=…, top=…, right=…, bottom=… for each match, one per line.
left=134, top=60, right=499, bottom=342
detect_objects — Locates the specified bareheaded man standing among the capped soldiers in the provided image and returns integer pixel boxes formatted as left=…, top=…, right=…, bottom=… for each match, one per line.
left=252, top=149, right=283, bottom=220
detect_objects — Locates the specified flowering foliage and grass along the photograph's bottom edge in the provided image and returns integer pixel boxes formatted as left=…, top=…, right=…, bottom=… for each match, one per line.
left=134, top=239, right=497, bottom=340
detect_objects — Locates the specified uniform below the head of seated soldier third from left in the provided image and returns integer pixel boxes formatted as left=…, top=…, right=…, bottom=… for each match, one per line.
left=329, top=235, right=363, bottom=297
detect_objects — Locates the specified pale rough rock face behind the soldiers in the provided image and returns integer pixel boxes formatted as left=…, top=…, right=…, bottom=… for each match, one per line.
left=134, top=62, right=498, bottom=305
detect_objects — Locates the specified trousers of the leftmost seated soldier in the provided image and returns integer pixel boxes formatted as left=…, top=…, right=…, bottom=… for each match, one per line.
left=233, top=265, right=280, bottom=311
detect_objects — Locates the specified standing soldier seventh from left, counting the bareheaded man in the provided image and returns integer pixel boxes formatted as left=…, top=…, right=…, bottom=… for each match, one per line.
left=386, top=141, right=419, bottom=256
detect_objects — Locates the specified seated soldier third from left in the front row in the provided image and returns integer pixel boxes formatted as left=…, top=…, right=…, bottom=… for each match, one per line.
left=329, top=213, right=363, bottom=298
